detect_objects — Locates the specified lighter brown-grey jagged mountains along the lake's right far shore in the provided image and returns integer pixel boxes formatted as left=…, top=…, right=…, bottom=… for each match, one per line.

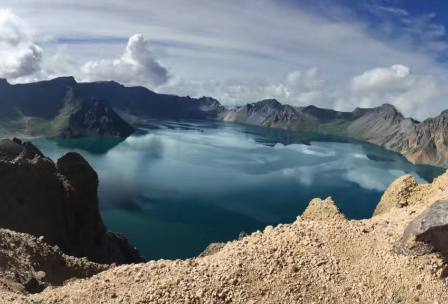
left=221, top=100, right=448, bottom=167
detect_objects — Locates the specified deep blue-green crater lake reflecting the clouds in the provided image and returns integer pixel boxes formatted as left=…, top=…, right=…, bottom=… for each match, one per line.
left=35, top=122, right=443, bottom=259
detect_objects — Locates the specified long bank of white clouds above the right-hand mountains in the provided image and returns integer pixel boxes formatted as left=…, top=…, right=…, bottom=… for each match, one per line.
left=160, top=64, right=448, bottom=119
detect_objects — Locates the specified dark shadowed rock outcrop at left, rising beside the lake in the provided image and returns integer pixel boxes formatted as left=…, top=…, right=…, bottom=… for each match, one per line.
left=0, top=139, right=142, bottom=264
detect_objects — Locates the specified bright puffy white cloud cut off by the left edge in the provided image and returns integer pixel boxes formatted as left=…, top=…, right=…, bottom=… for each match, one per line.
left=0, top=9, right=42, bottom=79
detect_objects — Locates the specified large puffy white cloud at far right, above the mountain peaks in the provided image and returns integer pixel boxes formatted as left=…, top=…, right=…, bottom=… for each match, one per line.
left=337, top=64, right=448, bottom=119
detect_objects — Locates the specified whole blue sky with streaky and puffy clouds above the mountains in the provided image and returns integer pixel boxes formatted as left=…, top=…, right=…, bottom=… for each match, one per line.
left=0, top=0, right=448, bottom=119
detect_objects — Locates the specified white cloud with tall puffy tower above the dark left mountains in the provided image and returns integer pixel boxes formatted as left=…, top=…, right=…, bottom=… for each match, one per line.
left=81, top=34, right=168, bottom=87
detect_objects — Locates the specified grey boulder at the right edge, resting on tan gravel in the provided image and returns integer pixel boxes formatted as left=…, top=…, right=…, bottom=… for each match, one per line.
left=396, top=201, right=448, bottom=257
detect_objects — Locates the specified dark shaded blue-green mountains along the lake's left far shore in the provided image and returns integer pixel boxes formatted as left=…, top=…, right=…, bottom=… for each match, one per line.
left=0, top=77, right=223, bottom=137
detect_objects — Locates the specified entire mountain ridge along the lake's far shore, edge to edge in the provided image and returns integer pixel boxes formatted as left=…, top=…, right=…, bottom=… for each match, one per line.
left=0, top=76, right=448, bottom=167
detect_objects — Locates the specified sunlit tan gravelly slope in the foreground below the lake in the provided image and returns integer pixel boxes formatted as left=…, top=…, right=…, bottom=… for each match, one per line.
left=0, top=167, right=448, bottom=304
